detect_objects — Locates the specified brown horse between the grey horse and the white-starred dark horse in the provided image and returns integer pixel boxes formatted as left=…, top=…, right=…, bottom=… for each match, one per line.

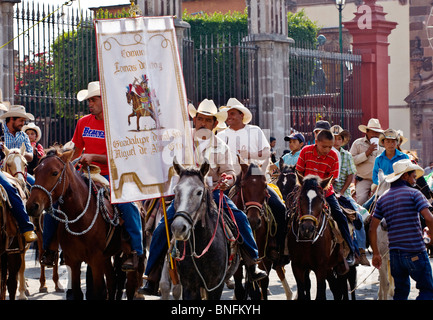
left=231, top=163, right=292, bottom=300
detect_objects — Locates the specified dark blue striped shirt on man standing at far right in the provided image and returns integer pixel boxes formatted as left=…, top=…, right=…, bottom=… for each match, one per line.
left=373, top=180, right=430, bottom=252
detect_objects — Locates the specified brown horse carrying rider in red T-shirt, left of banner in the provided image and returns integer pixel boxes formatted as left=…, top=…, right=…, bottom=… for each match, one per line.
left=26, top=148, right=142, bottom=300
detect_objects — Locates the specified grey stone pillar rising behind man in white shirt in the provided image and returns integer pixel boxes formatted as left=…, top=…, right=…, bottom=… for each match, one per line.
left=247, top=0, right=294, bottom=156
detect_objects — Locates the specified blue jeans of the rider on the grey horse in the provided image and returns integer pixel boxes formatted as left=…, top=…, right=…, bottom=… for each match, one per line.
left=144, top=190, right=259, bottom=275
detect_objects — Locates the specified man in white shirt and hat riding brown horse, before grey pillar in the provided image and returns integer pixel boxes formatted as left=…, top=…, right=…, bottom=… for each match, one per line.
left=218, top=98, right=286, bottom=262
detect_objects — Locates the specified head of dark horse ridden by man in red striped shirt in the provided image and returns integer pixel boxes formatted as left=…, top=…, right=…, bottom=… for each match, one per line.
left=296, top=172, right=332, bottom=241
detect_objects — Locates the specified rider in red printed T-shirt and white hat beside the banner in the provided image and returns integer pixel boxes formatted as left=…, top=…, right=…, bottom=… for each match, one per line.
left=41, top=81, right=143, bottom=270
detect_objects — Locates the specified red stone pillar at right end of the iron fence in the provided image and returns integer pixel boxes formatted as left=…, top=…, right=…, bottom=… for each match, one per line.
left=343, top=0, right=397, bottom=128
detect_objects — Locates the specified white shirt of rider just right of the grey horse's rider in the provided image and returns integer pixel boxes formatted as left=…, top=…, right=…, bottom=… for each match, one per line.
left=218, top=124, right=271, bottom=174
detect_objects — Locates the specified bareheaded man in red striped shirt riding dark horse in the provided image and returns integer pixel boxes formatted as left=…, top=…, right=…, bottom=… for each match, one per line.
left=296, top=130, right=355, bottom=266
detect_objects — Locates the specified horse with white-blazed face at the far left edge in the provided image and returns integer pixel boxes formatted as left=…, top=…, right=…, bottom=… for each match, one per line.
left=3, top=143, right=64, bottom=300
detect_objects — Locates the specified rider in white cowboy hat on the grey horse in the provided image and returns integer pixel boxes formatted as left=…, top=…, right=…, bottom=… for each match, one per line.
left=139, top=99, right=266, bottom=294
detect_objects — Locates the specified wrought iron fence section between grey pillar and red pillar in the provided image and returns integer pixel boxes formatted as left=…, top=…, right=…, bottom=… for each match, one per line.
left=290, top=42, right=362, bottom=143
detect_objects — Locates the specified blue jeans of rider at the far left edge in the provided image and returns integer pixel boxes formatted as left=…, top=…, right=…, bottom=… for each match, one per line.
left=0, top=171, right=35, bottom=233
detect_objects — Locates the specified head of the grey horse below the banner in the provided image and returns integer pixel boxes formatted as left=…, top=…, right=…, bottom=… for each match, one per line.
left=171, top=158, right=210, bottom=241
